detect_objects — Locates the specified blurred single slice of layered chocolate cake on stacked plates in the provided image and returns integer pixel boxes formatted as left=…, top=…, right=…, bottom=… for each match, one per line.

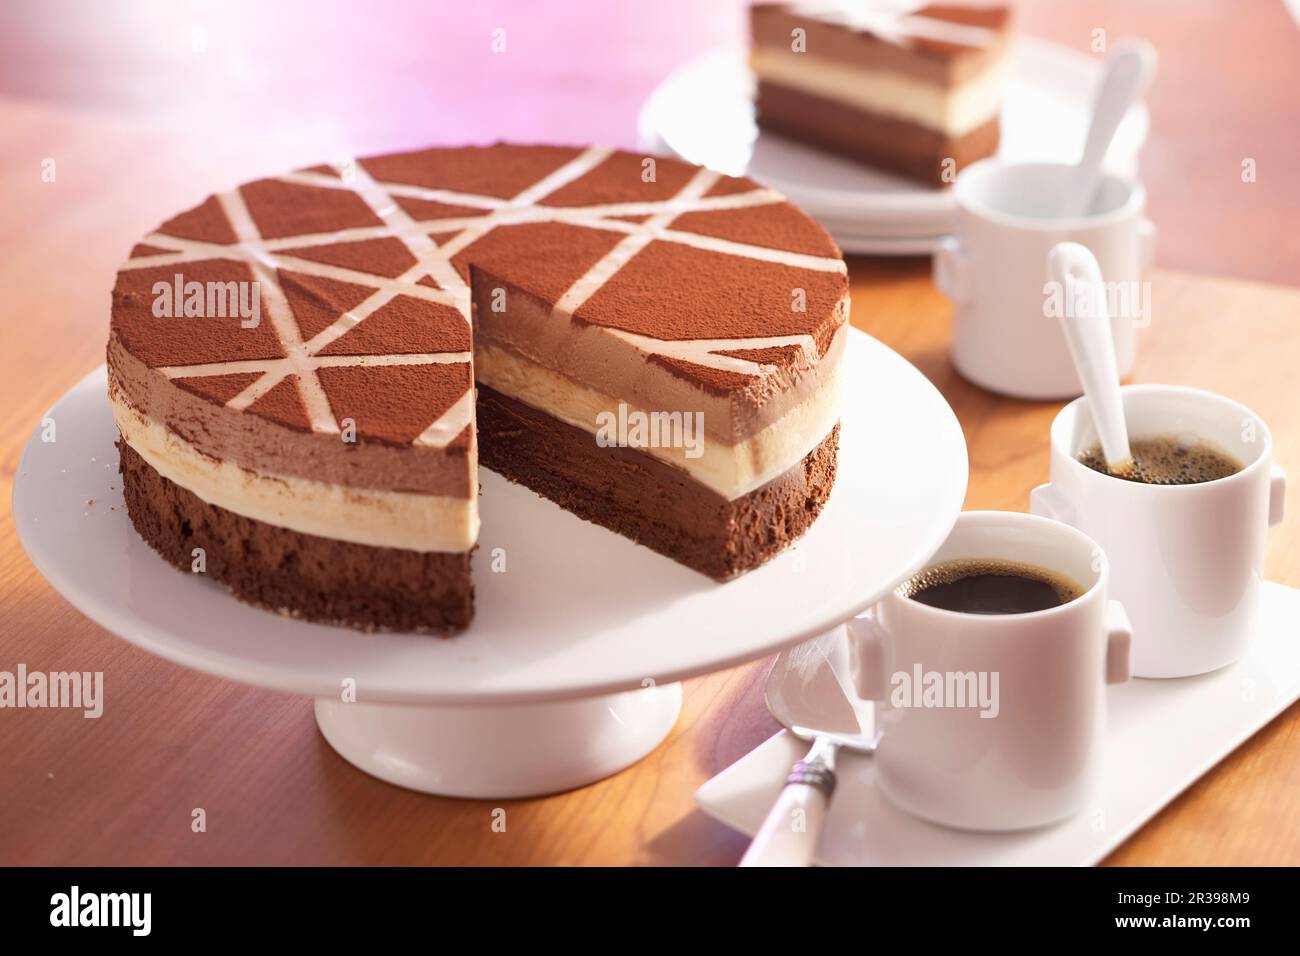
left=750, top=0, right=1010, bottom=185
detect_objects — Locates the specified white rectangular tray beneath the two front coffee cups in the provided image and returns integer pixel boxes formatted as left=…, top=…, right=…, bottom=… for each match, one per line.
left=696, top=581, right=1300, bottom=866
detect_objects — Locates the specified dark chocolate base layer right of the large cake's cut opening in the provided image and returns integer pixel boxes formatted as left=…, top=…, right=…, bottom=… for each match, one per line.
left=478, top=384, right=840, bottom=580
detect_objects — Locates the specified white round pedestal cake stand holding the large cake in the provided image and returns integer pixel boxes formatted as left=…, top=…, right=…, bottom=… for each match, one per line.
left=13, top=332, right=966, bottom=797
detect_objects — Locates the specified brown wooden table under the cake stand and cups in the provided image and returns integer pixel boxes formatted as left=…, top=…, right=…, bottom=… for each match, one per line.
left=0, top=240, right=1300, bottom=864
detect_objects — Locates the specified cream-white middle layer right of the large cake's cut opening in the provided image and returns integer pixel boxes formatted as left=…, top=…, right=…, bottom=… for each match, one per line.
left=475, top=342, right=840, bottom=501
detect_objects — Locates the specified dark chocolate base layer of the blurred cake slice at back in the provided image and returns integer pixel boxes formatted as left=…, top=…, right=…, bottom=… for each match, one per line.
left=757, top=79, right=998, bottom=186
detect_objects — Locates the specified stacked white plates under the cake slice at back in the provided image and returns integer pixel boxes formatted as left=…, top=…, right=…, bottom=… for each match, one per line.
left=637, top=38, right=1149, bottom=239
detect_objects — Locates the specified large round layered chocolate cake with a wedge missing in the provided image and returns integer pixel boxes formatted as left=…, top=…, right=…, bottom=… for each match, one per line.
left=108, top=144, right=848, bottom=632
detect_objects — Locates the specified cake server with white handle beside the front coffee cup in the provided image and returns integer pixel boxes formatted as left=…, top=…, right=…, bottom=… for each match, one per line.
left=740, top=627, right=876, bottom=866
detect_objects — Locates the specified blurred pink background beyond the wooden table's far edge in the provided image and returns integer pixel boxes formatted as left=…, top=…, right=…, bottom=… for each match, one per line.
left=0, top=0, right=1300, bottom=284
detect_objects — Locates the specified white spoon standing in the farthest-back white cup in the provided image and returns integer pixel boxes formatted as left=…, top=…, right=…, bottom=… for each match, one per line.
left=1057, top=38, right=1156, bottom=219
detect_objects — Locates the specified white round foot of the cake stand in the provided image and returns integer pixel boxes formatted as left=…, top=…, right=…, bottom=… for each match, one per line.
left=316, top=684, right=681, bottom=799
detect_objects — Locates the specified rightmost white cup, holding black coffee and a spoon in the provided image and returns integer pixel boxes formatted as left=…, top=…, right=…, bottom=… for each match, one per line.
left=1030, top=385, right=1286, bottom=678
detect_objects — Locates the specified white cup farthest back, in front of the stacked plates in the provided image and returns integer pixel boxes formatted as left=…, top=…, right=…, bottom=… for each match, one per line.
left=933, top=159, right=1156, bottom=399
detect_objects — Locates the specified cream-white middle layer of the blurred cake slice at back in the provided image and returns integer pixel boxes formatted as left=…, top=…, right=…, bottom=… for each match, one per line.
left=750, top=47, right=1006, bottom=137
